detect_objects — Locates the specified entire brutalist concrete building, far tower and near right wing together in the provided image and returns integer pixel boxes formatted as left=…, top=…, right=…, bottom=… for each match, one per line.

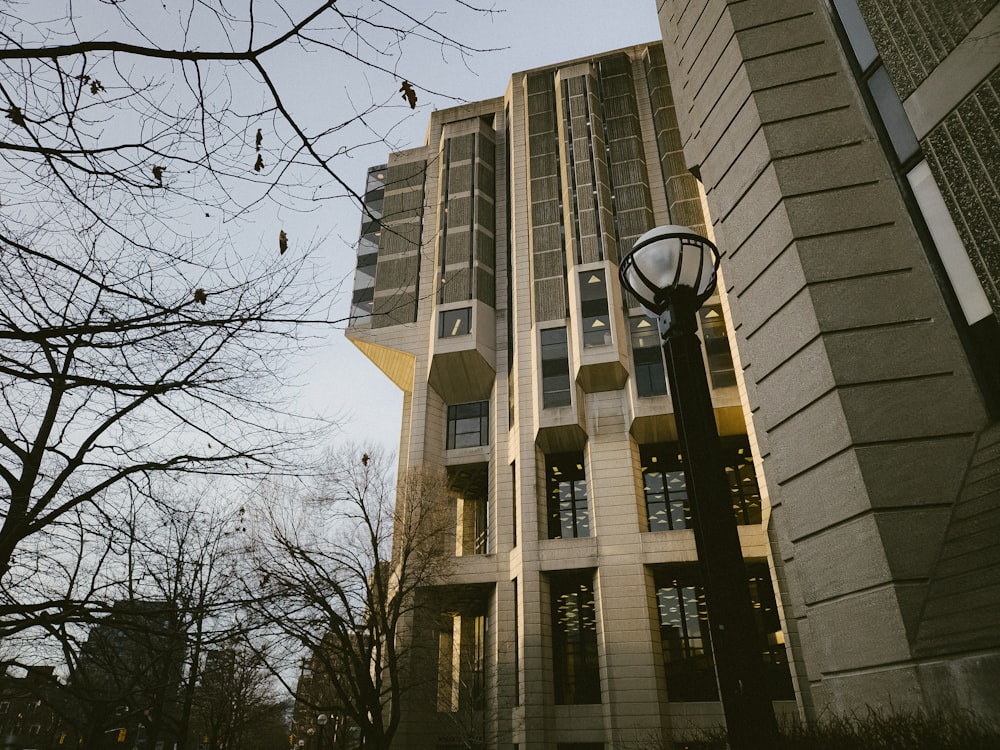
left=348, top=0, right=1000, bottom=750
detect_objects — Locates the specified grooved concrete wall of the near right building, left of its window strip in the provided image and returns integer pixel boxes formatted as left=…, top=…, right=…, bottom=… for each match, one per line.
left=659, top=0, right=988, bottom=724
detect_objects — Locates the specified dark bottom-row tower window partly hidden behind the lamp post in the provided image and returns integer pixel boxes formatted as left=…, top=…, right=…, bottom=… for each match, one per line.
left=654, top=563, right=794, bottom=701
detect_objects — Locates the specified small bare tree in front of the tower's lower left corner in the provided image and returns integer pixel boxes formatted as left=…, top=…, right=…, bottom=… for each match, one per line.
left=250, top=448, right=454, bottom=748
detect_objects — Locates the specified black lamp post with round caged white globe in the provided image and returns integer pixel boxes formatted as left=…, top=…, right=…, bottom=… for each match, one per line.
left=619, top=225, right=777, bottom=750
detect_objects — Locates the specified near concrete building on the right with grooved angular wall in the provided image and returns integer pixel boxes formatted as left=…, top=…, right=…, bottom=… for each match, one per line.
left=658, top=0, right=1000, bottom=718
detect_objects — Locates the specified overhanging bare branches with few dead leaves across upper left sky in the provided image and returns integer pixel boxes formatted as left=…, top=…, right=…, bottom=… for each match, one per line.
left=0, top=0, right=495, bottom=249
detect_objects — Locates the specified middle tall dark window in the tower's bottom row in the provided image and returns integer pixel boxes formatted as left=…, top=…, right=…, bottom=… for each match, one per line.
left=551, top=572, right=601, bottom=705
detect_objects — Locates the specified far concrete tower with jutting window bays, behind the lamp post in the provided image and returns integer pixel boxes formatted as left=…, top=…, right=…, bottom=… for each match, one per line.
left=348, top=43, right=795, bottom=750
